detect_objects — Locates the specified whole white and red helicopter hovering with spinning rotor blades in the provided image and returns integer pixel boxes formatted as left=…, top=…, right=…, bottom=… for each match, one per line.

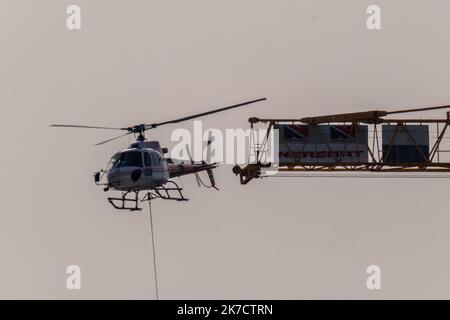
left=50, top=98, right=266, bottom=211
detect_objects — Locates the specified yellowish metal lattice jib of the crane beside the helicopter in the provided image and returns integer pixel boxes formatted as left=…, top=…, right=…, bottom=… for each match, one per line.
left=233, top=106, right=450, bottom=184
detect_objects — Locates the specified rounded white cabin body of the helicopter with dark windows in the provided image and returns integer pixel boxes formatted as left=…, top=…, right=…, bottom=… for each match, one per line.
left=107, top=145, right=169, bottom=191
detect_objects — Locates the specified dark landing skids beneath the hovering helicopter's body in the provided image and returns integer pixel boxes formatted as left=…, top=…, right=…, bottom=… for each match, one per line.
left=108, top=181, right=189, bottom=211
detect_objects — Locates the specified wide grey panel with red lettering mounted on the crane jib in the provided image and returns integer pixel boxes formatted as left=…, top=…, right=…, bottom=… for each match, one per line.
left=275, top=124, right=368, bottom=164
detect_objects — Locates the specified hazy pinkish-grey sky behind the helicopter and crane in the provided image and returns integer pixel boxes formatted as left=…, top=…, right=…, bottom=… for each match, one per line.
left=0, top=0, right=450, bottom=299
